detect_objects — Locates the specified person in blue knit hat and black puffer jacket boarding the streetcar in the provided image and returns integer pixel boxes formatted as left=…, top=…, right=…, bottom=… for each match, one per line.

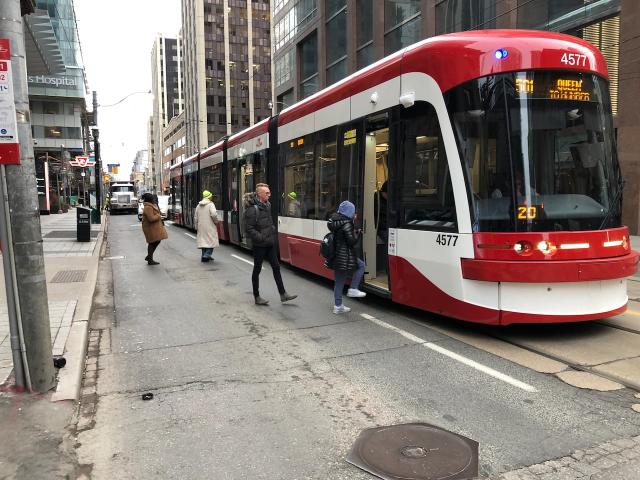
left=327, top=200, right=366, bottom=314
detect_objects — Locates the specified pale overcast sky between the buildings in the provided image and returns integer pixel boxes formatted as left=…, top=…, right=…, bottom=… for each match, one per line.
left=74, top=0, right=181, bottom=179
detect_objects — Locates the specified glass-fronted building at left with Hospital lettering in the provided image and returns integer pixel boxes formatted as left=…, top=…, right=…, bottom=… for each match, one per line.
left=24, top=0, right=89, bottom=212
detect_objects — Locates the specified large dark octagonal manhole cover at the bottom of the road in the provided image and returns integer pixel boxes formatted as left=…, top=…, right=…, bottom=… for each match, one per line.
left=347, top=423, right=478, bottom=480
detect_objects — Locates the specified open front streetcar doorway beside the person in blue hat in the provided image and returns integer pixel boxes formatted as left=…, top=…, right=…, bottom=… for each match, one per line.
left=362, top=112, right=389, bottom=290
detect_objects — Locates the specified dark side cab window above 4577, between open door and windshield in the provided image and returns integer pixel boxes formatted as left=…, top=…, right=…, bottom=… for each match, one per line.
left=400, top=102, right=457, bottom=231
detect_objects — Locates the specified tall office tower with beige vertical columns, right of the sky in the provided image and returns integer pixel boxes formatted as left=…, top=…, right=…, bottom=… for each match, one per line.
left=182, top=0, right=271, bottom=155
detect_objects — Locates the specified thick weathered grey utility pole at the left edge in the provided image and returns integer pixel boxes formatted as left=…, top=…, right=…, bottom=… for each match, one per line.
left=0, top=0, right=55, bottom=393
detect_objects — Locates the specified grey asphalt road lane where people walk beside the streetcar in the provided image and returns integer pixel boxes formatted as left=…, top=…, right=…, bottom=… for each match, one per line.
left=78, top=216, right=640, bottom=479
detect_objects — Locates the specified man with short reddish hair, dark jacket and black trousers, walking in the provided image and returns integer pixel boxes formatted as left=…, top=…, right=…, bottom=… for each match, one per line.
left=244, top=183, right=297, bottom=305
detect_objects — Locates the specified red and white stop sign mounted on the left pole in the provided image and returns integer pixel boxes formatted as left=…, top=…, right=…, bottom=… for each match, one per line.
left=0, top=38, right=20, bottom=165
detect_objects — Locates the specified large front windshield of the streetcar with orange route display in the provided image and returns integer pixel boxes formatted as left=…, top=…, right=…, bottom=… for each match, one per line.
left=446, top=71, right=622, bottom=232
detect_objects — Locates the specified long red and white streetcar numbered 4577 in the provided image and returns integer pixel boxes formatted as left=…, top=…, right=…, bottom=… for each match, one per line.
left=171, top=30, right=638, bottom=326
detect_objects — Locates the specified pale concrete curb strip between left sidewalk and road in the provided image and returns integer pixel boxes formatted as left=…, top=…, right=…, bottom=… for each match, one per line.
left=51, top=215, right=107, bottom=402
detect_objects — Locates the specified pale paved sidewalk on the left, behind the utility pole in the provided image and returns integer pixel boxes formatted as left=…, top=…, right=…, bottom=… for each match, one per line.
left=0, top=209, right=105, bottom=400
